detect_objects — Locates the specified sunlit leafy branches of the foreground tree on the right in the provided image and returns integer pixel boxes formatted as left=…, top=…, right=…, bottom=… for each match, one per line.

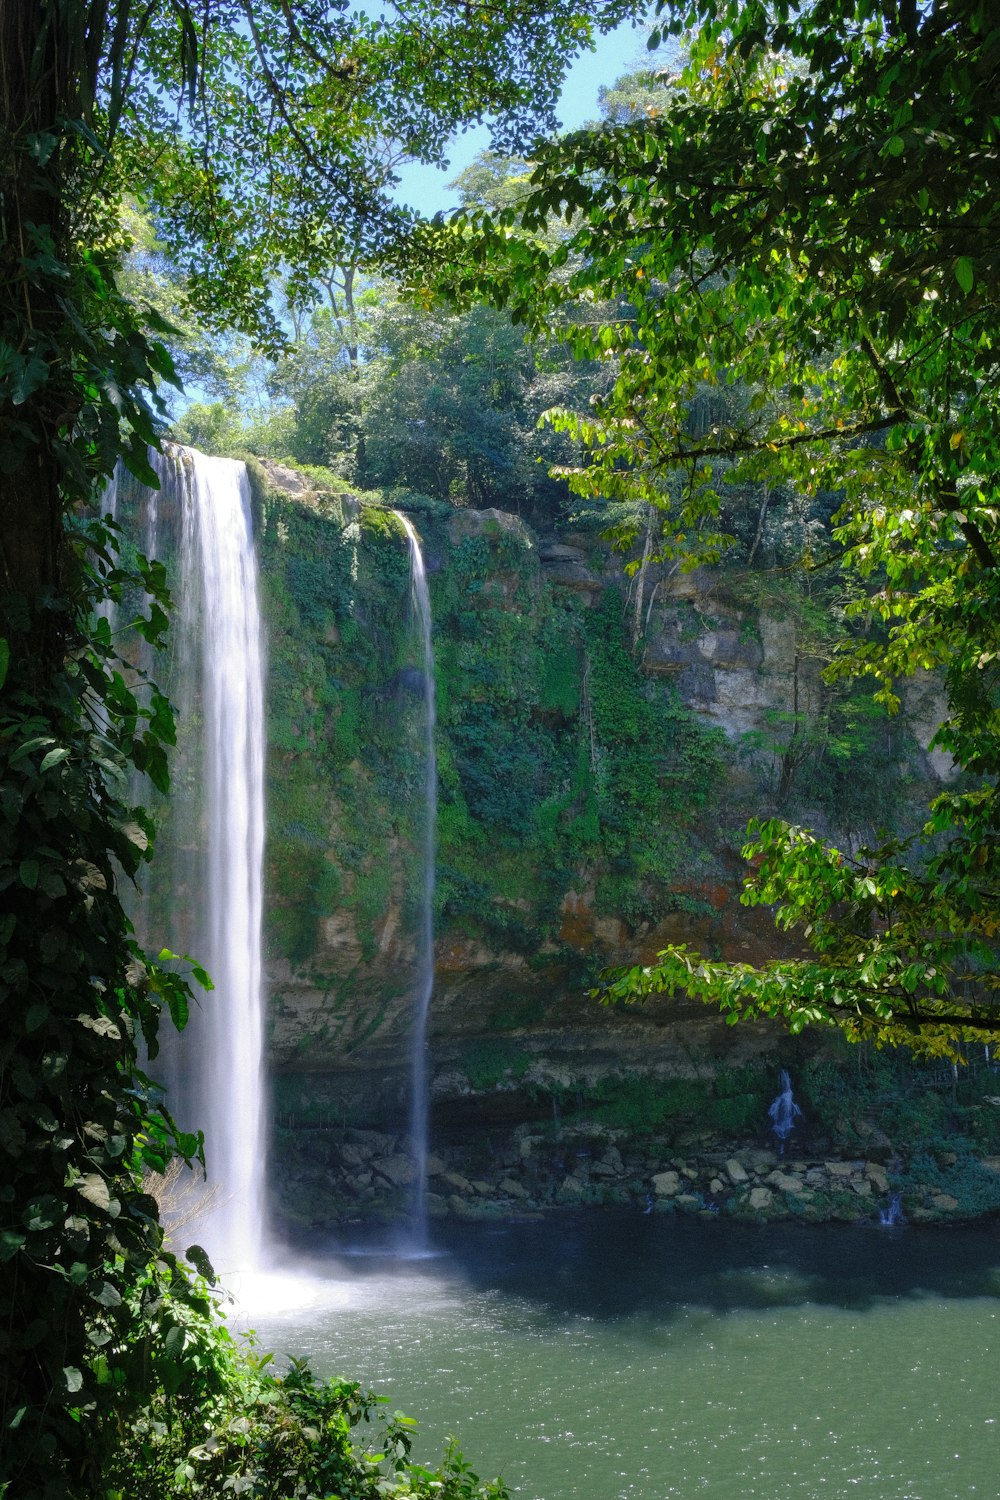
left=409, top=0, right=1000, bottom=1052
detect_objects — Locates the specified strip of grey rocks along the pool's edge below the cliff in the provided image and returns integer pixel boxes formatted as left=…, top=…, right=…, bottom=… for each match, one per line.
left=273, top=1125, right=1000, bottom=1229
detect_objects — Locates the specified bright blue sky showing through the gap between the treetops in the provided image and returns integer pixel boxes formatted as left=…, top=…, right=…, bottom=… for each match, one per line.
left=396, top=10, right=649, bottom=215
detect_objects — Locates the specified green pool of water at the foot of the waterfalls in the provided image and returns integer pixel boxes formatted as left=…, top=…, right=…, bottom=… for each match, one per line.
left=237, top=1214, right=1000, bottom=1500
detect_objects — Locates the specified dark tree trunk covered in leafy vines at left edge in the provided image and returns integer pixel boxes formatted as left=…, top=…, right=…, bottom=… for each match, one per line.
left=0, top=0, right=189, bottom=1500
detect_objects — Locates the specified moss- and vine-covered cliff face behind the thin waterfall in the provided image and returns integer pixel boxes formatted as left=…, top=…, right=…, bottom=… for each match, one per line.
left=255, top=465, right=948, bottom=1128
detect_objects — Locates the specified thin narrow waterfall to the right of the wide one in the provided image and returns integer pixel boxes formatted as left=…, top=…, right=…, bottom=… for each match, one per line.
left=394, top=510, right=438, bottom=1244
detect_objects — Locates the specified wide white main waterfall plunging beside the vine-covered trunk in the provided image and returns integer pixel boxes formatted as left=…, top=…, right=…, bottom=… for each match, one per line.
left=128, top=449, right=264, bottom=1272
